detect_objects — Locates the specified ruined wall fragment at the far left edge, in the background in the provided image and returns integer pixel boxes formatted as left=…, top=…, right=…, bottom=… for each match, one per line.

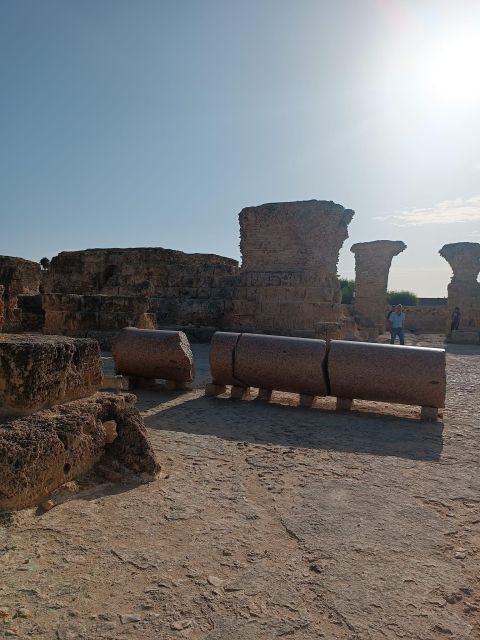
left=0, top=256, right=41, bottom=331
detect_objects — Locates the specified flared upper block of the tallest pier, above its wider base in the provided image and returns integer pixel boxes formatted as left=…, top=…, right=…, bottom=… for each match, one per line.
left=239, top=200, right=354, bottom=274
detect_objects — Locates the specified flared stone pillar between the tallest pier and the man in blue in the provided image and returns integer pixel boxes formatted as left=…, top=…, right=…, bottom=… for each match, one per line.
left=350, top=240, right=407, bottom=333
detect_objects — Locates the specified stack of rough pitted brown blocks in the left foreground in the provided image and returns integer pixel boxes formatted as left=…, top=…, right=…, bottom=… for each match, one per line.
left=0, top=334, right=159, bottom=511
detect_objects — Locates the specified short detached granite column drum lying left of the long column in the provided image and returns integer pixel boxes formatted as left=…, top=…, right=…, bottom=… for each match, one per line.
left=112, top=327, right=194, bottom=382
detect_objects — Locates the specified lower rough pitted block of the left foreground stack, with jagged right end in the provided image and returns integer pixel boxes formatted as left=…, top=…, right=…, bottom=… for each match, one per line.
left=0, top=393, right=159, bottom=511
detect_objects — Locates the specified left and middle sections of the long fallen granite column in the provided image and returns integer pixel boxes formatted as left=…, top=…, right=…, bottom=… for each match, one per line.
left=210, top=332, right=327, bottom=396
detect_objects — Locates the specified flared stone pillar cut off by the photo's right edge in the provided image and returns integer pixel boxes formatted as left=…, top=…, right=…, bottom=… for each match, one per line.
left=439, top=242, right=480, bottom=334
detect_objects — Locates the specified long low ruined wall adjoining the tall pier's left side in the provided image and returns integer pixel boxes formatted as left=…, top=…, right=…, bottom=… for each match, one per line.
left=44, top=248, right=238, bottom=333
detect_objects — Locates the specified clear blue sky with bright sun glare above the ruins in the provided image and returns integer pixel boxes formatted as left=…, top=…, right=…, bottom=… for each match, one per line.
left=0, top=0, right=480, bottom=296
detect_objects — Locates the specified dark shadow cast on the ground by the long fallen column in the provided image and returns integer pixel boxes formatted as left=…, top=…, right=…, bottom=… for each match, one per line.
left=145, top=396, right=443, bottom=461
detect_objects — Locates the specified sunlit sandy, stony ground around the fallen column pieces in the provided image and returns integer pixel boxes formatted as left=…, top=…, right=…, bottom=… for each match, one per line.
left=0, top=336, right=480, bottom=640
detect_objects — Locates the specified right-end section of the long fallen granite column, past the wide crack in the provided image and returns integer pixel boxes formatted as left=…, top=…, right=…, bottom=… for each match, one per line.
left=328, top=340, right=446, bottom=408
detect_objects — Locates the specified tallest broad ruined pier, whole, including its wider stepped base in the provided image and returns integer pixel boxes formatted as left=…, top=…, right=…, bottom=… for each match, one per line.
left=226, top=200, right=354, bottom=335
